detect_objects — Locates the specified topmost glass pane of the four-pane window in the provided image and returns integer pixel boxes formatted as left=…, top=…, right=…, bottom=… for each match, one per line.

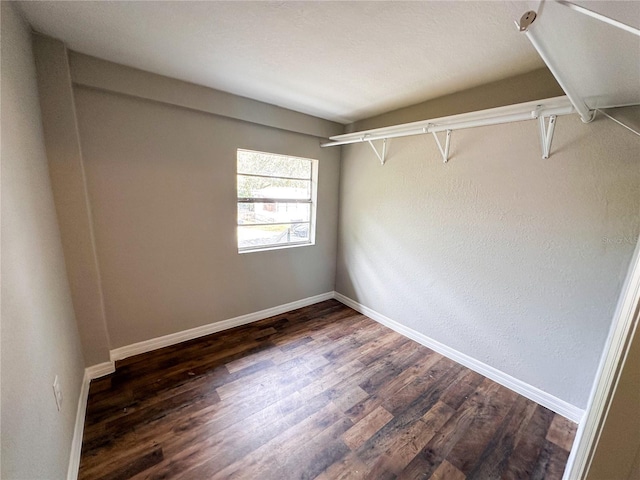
left=238, top=150, right=311, bottom=179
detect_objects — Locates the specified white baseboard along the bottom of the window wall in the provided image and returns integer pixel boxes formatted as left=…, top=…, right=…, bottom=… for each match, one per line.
left=109, top=292, right=334, bottom=362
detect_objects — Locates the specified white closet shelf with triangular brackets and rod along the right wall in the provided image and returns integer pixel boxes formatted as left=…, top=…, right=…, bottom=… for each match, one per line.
left=321, top=0, right=640, bottom=165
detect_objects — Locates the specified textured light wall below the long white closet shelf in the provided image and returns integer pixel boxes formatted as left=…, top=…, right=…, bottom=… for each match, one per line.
left=336, top=107, right=640, bottom=408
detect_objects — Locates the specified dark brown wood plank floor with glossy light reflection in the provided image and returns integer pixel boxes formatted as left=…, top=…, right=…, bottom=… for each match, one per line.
left=79, top=300, right=576, bottom=480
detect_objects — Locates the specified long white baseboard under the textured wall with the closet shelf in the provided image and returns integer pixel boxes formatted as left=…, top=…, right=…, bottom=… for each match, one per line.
left=334, top=292, right=584, bottom=423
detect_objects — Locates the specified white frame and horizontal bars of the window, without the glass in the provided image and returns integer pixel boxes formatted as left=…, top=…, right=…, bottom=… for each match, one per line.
left=236, top=148, right=318, bottom=254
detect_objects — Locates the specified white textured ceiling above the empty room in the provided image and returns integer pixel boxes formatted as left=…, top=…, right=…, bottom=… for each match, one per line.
left=20, top=1, right=544, bottom=123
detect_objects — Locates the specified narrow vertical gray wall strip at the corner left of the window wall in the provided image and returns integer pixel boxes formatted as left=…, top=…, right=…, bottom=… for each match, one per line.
left=33, top=34, right=109, bottom=366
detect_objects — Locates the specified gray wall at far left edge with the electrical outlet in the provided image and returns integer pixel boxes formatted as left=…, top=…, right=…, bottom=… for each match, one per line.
left=0, top=2, right=84, bottom=480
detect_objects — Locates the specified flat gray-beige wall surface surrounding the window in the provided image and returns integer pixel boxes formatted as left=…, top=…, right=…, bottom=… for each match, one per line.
left=75, top=83, right=340, bottom=348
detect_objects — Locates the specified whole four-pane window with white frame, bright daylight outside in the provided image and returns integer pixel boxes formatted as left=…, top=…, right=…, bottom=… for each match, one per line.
left=237, top=149, right=318, bottom=252
